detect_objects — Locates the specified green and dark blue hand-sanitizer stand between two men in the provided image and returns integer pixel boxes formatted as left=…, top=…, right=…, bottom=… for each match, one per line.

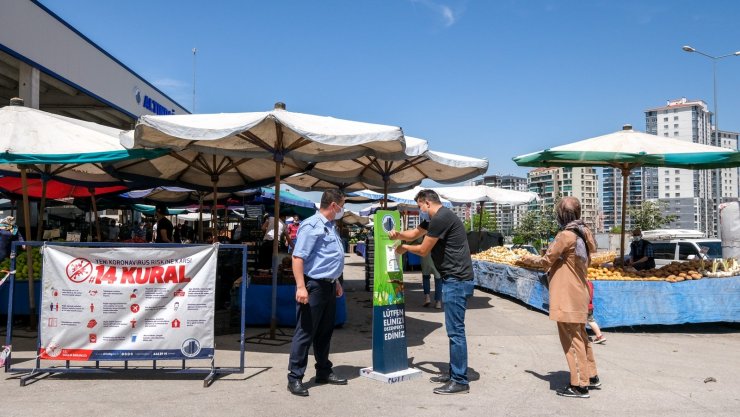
left=373, top=211, right=408, bottom=374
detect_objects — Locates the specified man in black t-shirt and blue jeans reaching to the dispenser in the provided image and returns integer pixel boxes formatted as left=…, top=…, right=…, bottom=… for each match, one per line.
left=388, top=190, right=474, bottom=394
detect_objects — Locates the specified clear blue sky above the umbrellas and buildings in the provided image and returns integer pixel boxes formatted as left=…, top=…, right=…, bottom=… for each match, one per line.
left=41, top=0, right=740, bottom=180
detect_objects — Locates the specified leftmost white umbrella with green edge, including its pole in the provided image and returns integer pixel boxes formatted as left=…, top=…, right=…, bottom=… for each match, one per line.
left=0, top=99, right=159, bottom=323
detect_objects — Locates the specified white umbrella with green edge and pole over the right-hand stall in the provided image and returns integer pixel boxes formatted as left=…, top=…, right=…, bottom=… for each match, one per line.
left=513, top=125, right=740, bottom=259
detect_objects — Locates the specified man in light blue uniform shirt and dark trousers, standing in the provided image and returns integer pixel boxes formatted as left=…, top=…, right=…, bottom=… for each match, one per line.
left=288, top=190, right=347, bottom=397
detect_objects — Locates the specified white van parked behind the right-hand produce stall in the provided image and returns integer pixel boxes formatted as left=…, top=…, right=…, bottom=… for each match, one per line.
left=642, top=229, right=722, bottom=268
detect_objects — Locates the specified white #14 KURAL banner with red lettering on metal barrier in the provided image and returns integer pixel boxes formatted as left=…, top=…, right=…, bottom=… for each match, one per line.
left=39, top=245, right=218, bottom=361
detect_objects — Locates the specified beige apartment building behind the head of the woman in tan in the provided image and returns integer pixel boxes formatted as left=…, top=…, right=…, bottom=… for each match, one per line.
left=527, top=167, right=601, bottom=232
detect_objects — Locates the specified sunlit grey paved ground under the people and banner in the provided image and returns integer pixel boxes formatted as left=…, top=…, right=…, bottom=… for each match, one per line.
left=0, top=255, right=740, bottom=417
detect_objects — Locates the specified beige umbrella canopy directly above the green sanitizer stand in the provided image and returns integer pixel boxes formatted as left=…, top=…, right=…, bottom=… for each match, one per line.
left=289, top=136, right=488, bottom=206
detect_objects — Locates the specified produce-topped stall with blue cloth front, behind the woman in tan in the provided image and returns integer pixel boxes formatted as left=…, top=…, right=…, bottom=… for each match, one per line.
left=473, top=247, right=740, bottom=328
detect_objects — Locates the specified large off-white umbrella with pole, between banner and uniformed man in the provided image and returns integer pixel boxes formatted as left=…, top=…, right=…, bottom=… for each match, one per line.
left=116, top=103, right=405, bottom=337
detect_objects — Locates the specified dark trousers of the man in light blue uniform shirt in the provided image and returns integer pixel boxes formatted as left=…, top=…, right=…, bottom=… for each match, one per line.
left=288, top=279, right=337, bottom=381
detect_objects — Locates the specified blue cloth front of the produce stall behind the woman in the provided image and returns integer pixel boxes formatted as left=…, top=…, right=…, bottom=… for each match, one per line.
left=473, top=260, right=740, bottom=328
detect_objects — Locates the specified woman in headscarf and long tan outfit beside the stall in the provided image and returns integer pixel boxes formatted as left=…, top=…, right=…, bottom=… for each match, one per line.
left=526, top=197, right=601, bottom=398
